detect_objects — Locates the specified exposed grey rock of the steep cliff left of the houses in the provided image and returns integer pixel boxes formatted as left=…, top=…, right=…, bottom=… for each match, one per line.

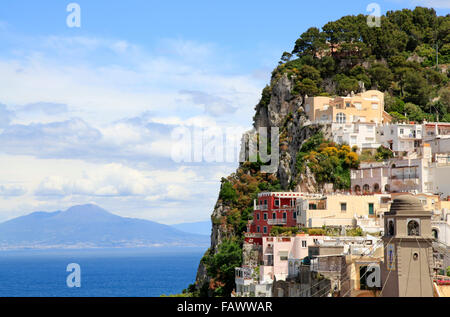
left=196, top=75, right=330, bottom=289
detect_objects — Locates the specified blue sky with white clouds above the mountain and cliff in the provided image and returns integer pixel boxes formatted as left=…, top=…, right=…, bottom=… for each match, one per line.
left=0, top=0, right=450, bottom=224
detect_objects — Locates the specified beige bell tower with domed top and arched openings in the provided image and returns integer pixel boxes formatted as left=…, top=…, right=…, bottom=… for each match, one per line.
left=381, top=195, right=433, bottom=297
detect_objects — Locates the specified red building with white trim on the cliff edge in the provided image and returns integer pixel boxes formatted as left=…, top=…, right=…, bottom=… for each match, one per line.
left=247, top=192, right=303, bottom=237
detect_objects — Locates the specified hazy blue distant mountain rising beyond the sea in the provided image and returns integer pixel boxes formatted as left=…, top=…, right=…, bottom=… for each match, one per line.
left=0, top=205, right=209, bottom=249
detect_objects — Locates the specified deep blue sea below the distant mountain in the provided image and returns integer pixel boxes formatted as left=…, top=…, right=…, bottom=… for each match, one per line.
left=0, top=248, right=206, bottom=297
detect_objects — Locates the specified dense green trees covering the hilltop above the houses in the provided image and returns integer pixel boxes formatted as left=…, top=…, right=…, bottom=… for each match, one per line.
left=272, top=7, right=450, bottom=122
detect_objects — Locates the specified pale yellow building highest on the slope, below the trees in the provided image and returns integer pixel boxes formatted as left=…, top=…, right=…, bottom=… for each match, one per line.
left=305, top=90, right=391, bottom=124
